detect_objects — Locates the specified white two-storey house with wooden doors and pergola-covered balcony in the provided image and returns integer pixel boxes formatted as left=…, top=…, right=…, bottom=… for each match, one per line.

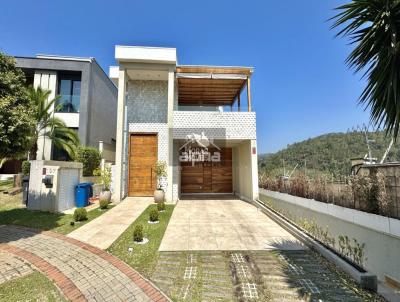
left=110, top=46, right=258, bottom=202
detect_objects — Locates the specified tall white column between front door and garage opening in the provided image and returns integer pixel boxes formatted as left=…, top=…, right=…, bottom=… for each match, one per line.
left=166, top=67, right=175, bottom=202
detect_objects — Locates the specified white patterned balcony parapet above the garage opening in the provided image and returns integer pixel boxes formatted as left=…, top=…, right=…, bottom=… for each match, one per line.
left=173, top=111, right=256, bottom=139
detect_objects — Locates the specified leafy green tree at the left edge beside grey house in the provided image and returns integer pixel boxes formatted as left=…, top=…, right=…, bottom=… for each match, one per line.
left=0, top=52, right=35, bottom=166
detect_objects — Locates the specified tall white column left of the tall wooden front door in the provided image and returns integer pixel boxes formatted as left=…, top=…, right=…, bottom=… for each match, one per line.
left=113, top=67, right=126, bottom=202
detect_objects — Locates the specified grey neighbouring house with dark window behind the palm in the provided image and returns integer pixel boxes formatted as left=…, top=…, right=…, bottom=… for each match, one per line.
left=16, top=55, right=118, bottom=161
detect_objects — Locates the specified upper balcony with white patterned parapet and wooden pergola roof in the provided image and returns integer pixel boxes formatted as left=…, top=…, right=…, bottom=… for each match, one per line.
left=173, top=66, right=256, bottom=140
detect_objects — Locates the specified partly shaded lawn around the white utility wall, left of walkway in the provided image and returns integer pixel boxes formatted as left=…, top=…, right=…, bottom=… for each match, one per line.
left=0, top=193, right=112, bottom=234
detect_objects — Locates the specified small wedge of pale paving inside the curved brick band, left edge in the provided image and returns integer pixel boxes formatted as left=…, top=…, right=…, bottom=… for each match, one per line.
left=0, top=251, right=34, bottom=284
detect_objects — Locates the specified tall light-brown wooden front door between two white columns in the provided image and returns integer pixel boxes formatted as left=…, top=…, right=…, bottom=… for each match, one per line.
left=128, top=134, right=158, bottom=196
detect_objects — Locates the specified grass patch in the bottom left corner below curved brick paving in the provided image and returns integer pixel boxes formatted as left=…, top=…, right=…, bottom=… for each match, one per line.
left=0, top=272, right=66, bottom=302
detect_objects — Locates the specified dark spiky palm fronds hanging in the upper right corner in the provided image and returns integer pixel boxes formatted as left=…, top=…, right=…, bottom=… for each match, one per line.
left=332, top=0, right=400, bottom=137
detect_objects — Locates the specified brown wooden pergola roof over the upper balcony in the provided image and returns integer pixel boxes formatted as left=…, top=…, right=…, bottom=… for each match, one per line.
left=176, top=66, right=253, bottom=111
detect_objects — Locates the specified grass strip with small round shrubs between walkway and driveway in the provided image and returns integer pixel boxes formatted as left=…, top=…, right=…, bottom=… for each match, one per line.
left=108, top=204, right=174, bottom=278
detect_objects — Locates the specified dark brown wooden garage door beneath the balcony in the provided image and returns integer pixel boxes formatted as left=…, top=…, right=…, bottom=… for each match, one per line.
left=181, top=148, right=232, bottom=193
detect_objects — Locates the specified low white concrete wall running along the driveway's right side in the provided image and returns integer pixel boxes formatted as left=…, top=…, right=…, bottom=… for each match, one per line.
left=260, top=189, right=400, bottom=280
